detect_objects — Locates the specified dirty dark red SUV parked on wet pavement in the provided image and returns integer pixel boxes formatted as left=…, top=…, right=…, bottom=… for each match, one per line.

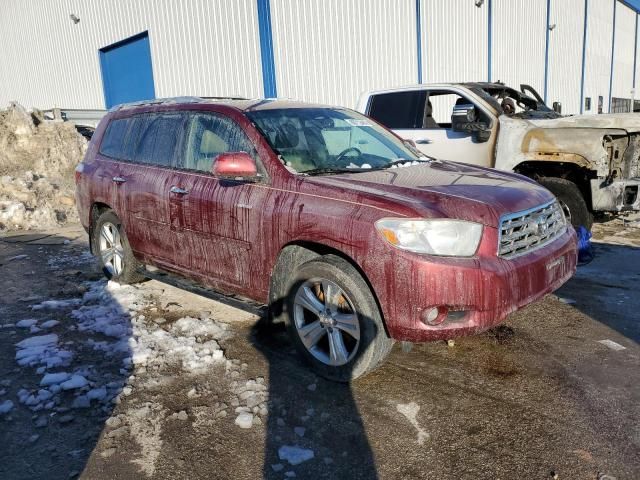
left=76, top=98, right=576, bottom=381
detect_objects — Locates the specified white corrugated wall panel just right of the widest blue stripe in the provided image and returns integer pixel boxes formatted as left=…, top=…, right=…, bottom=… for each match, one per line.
left=271, top=0, right=417, bottom=107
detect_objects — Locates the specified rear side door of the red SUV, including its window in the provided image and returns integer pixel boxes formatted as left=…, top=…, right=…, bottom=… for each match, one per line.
left=120, top=112, right=186, bottom=266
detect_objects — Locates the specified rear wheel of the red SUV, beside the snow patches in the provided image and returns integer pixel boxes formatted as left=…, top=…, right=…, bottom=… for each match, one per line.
left=93, top=210, right=145, bottom=284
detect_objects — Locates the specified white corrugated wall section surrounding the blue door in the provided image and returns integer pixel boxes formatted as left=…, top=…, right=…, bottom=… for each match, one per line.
left=0, top=0, right=262, bottom=108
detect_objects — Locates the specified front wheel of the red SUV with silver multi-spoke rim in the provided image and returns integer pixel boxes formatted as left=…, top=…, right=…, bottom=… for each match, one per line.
left=284, top=255, right=393, bottom=382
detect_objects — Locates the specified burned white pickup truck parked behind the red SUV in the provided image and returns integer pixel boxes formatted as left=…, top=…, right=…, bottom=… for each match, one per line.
left=358, top=82, right=640, bottom=228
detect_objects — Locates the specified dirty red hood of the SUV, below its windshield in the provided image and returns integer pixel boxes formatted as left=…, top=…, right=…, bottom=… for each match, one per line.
left=307, top=160, right=554, bottom=227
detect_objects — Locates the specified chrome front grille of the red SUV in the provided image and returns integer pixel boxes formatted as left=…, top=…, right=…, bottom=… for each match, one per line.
left=498, top=201, right=567, bottom=258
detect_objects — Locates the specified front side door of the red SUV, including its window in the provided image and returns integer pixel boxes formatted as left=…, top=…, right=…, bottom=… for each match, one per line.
left=170, top=112, right=267, bottom=297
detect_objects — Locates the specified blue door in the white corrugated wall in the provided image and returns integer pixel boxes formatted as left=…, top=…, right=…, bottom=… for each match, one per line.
left=100, top=32, right=156, bottom=108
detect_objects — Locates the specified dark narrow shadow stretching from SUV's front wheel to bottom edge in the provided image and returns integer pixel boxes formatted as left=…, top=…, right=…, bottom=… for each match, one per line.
left=250, top=286, right=378, bottom=479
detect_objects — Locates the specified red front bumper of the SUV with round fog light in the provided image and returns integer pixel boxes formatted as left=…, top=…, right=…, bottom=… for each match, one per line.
left=372, top=227, right=577, bottom=342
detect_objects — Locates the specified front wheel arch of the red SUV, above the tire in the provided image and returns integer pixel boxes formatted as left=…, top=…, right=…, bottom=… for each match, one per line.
left=269, top=241, right=391, bottom=338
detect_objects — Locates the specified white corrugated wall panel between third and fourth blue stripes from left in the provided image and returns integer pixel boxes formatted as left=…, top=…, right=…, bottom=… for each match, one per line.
left=491, top=0, right=547, bottom=94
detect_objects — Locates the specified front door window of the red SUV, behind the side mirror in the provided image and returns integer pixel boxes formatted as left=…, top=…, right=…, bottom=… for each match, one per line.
left=179, top=113, right=258, bottom=172
